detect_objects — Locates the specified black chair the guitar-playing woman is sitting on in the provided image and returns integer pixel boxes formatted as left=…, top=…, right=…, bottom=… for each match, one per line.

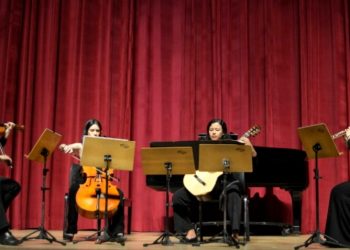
left=195, top=173, right=250, bottom=244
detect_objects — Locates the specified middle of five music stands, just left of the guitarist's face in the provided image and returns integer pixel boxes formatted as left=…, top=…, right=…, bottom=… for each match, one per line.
left=141, top=147, right=195, bottom=247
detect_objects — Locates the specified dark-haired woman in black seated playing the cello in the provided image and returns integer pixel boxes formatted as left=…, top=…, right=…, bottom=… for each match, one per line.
left=60, top=119, right=125, bottom=243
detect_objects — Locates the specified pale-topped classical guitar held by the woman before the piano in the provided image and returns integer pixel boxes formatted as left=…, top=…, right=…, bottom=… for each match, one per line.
left=183, top=125, right=261, bottom=196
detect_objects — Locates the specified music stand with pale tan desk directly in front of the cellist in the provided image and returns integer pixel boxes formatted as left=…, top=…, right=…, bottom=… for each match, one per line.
left=80, top=136, right=135, bottom=246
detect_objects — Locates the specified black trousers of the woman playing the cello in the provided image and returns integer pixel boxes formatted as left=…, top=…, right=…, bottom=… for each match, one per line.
left=65, top=164, right=124, bottom=236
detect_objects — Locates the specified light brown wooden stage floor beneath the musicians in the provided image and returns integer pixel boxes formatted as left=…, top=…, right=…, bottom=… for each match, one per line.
left=5, top=230, right=344, bottom=250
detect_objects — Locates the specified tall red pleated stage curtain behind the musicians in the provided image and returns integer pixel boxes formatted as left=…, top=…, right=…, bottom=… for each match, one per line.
left=0, top=0, right=350, bottom=233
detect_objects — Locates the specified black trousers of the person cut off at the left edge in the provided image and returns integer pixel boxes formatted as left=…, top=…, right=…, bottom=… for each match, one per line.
left=0, top=176, right=21, bottom=231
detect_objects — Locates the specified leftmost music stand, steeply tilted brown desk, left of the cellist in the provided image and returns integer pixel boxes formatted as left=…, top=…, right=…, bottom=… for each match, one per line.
left=21, top=128, right=66, bottom=245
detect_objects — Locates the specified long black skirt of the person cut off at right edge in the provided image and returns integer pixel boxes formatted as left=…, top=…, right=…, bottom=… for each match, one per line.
left=325, top=182, right=350, bottom=247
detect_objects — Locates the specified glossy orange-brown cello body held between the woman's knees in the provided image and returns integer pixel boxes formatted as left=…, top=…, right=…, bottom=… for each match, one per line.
left=75, top=166, right=120, bottom=219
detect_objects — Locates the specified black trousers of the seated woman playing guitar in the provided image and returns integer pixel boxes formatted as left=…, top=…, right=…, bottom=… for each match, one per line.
left=173, top=174, right=242, bottom=234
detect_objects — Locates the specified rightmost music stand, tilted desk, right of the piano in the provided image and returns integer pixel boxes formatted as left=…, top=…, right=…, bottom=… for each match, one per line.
left=294, top=123, right=341, bottom=250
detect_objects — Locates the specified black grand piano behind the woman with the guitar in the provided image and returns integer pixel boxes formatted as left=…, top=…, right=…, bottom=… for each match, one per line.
left=146, top=141, right=309, bottom=233
